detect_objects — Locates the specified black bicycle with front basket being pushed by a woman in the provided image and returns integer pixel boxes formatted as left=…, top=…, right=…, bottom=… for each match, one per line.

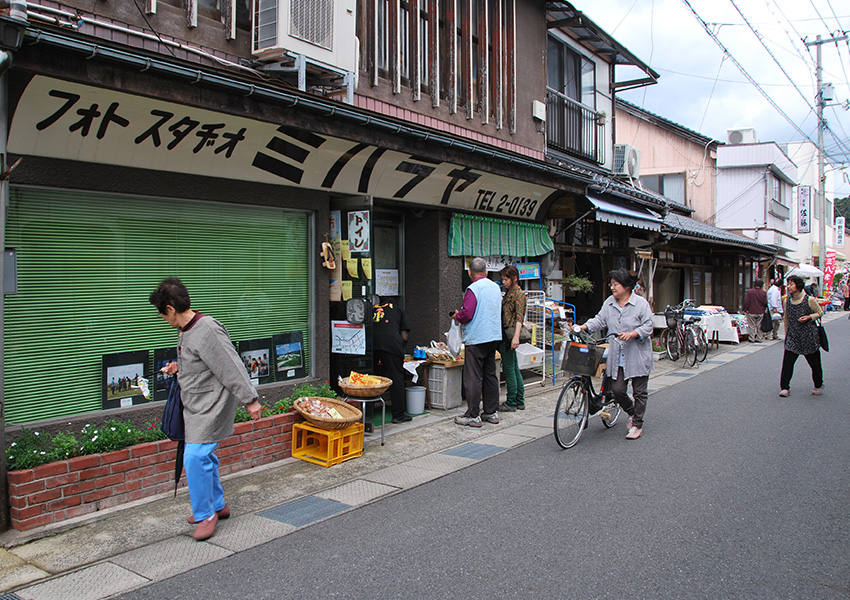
left=554, top=329, right=620, bottom=449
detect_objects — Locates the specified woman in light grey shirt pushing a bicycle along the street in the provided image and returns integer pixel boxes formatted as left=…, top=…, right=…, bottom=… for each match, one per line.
left=581, top=269, right=653, bottom=440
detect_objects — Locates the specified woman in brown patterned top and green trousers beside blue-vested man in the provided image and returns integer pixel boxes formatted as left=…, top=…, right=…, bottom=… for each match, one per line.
left=499, top=265, right=525, bottom=412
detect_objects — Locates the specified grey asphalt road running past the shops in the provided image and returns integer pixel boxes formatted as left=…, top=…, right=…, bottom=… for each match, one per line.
left=121, top=319, right=850, bottom=600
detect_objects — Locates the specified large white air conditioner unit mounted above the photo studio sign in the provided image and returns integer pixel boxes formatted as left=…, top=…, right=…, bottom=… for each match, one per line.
left=251, top=0, right=358, bottom=72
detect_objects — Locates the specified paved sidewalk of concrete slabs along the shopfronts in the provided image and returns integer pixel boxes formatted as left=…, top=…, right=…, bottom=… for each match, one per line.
left=0, top=313, right=846, bottom=600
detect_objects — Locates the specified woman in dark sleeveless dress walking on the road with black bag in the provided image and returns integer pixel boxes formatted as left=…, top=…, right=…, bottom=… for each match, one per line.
left=779, top=275, right=823, bottom=397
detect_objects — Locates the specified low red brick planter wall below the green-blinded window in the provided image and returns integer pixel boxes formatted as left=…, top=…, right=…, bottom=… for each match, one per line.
left=8, top=412, right=301, bottom=531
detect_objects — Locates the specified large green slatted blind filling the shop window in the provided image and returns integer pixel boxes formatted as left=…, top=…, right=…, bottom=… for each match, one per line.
left=4, top=188, right=311, bottom=423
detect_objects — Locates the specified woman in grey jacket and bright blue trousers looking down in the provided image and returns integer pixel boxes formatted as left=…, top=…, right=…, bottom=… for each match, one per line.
left=149, top=277, right=262, bottom=540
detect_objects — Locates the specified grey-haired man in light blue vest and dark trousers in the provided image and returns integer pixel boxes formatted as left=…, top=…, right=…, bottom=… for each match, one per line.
left=451, top=258, right=502, bottom=427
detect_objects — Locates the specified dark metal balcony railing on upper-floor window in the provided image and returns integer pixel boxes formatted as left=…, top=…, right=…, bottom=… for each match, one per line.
left=546, top=88, right=605, bottom=165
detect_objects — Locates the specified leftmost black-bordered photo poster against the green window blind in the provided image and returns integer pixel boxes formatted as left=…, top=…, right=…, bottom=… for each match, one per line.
left=101, top=350, right=150, bottom=409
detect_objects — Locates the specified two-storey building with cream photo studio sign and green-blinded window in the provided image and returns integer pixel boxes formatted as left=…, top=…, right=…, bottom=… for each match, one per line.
left=0, top=0, right=667, bottom=446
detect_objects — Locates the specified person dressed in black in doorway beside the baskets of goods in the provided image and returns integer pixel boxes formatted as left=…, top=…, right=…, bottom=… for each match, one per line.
left=370, top=296, right=413, bottom=423
